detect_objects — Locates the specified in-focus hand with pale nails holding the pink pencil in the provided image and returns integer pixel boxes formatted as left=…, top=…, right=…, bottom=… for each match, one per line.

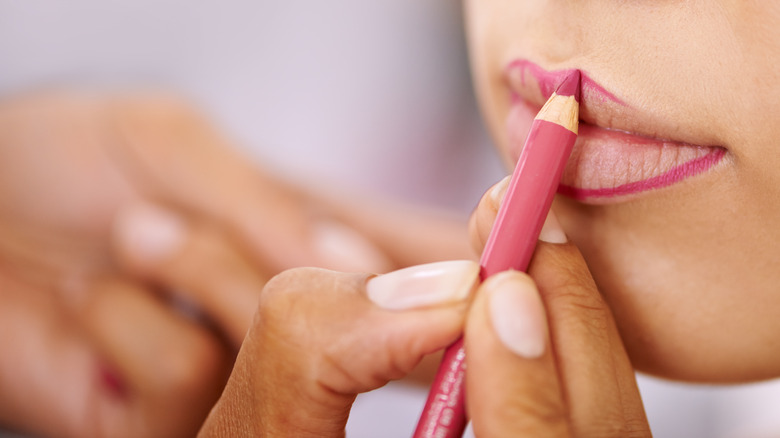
left=200, top=204, right=650, bottom=438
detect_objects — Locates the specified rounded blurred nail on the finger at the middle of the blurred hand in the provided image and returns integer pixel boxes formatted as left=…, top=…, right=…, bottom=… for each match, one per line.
left=115, top=205, right=185, bottom=262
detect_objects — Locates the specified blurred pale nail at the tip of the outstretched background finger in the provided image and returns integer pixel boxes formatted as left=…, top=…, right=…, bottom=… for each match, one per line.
left=312, top=221, right=392, bottom=272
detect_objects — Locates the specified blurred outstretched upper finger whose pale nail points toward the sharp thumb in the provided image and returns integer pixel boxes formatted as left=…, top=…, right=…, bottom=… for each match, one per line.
left=112, top=97, right=388, bottom=274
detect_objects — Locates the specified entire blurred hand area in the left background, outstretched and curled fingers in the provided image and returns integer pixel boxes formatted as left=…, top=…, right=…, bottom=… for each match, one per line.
left=0, top=94, right=408, bottom=437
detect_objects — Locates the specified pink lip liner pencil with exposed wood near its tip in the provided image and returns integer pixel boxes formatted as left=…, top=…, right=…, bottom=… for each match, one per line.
left=414, top=70, right=580, bottom=438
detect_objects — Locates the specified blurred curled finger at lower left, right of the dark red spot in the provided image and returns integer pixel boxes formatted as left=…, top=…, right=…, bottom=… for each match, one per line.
left=82, top=279, right=230, bottom=437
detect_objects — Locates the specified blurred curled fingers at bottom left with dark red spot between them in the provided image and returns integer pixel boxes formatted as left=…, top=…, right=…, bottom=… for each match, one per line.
left=0, top=262, right=232, bottom=438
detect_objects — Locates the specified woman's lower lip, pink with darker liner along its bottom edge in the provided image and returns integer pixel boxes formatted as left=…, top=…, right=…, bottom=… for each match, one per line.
left=507, top=101, right=726, bottom=204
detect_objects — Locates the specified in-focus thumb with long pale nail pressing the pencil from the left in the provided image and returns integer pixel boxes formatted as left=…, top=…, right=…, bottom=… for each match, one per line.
left=201, top=261, right=479, bottom=437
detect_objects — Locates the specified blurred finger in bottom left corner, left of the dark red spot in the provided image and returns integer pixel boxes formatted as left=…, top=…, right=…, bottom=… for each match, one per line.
left=0, top=266, right=94, bottom=437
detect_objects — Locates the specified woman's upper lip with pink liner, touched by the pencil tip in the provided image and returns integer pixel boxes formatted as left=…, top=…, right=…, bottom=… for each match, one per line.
left=505, top=59, right=715, bottom=146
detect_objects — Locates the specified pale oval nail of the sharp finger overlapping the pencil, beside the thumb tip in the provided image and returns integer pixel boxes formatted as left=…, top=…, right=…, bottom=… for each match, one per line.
left=485, top=271, right=547, bottom=359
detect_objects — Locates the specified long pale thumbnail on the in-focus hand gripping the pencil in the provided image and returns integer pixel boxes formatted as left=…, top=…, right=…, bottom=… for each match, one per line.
left=366, top=260, right=479, bottom=310
